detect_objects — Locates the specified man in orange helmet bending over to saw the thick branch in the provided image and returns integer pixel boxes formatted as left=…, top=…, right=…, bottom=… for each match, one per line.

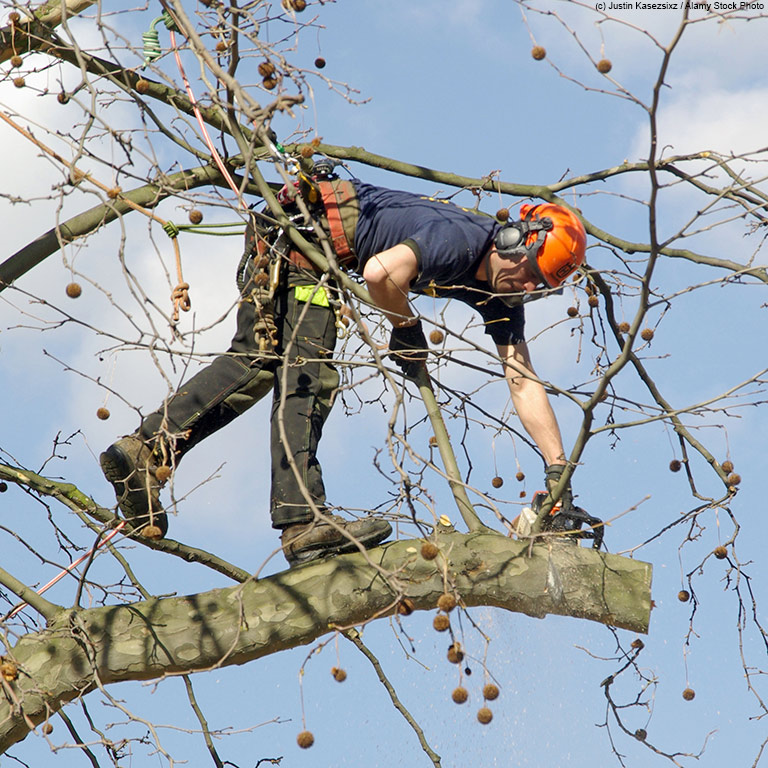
left=101, top=166, right=586, bottom=565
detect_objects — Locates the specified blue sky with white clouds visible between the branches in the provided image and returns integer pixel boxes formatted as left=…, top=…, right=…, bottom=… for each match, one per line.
left=0, top=0, right=768, bottom=768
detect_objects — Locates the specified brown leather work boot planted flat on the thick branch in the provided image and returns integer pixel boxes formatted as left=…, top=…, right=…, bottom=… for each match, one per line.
left=280, top=515, right=392, bottom=567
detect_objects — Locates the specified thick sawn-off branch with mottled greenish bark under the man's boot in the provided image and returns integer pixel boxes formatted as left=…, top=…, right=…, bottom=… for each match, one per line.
left=0, top=529, right=651, bottom=753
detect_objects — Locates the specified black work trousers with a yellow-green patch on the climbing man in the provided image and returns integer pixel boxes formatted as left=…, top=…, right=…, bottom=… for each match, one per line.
left=139, top=266, right=339, bottom=528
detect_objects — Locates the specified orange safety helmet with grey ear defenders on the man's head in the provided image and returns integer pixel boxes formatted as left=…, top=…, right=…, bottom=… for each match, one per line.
left=495, top=203, right=587, bottom=288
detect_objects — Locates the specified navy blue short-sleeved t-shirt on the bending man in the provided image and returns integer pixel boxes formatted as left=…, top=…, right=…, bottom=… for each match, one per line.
left=352, top=179, right=525, bottom=344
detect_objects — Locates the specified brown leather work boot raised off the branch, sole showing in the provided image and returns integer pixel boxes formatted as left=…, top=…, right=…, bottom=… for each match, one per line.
left=99, top=435, right=168, bottom=539
